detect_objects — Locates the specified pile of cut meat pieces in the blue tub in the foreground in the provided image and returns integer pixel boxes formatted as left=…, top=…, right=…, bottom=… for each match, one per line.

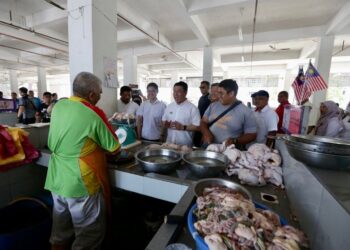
left=194, top=187, right=308, bottom=250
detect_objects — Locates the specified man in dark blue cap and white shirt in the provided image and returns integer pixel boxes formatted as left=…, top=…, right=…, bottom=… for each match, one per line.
left=254, top=90, right=278, bottom=147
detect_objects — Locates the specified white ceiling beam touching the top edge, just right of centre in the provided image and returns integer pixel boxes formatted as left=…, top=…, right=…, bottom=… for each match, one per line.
left=188, top=0, right=250, bottom=15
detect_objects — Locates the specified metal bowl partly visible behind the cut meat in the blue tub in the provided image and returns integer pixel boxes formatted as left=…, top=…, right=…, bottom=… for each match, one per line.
left=194, top=178, right=252, bottom=200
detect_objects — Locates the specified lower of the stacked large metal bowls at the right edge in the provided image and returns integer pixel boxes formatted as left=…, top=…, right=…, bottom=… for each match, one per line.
left=286, top=143, right=350, bottom=170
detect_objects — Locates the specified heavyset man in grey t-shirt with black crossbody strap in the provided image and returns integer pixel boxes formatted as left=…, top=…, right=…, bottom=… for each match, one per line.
left=201, top=79, right=257, bottom=146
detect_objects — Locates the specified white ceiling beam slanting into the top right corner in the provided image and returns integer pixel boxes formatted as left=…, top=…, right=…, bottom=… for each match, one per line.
left=326, top=2, right=350, bottom=35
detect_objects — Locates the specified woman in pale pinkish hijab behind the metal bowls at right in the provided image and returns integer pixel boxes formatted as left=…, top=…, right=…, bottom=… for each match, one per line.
left=315, top=101, right=344, bottom=137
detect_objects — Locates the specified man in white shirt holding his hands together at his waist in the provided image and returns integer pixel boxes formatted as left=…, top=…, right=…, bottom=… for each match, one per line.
left=162, top=81, right=201, bottom=146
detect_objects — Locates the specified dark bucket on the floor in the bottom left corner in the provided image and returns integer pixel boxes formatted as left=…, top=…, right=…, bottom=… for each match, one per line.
left=0, top=197, right=52, bottom=250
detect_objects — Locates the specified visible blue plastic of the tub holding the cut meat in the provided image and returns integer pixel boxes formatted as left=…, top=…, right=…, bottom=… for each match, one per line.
left=187, top=202, right=288, bottom=250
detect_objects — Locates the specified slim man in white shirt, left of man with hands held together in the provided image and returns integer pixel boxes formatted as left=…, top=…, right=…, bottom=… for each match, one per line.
left=137, top=82, right=166, bottom=141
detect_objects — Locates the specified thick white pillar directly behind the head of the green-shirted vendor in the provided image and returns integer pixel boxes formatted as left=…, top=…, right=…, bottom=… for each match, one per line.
left=68, top=0, right=117, bottom=116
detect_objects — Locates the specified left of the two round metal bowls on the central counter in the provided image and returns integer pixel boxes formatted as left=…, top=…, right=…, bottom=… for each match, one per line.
left=135, top=149, right=181, bottom=174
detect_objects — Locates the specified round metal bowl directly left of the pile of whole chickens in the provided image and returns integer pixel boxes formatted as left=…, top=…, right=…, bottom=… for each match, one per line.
left=182, top=150, right=229, bottom=178
